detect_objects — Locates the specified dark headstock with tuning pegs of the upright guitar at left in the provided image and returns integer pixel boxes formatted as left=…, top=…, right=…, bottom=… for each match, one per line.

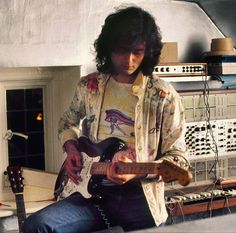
left=7, top=166, right=24, bottom=193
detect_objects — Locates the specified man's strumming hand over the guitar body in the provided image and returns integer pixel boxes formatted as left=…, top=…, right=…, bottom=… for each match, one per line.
left=64, top=140, right=82, bottom=184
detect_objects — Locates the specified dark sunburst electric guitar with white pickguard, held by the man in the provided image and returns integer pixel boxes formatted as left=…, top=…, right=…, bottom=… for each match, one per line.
left=55, top=136, right=192, bottom=198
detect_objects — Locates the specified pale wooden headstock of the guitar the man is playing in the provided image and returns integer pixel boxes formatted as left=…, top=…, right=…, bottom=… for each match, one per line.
left=159, top=159, right=193, bottom=186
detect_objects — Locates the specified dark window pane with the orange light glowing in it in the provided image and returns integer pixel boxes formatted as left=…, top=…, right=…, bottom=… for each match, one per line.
left=26, top=111, right=43, bottom=132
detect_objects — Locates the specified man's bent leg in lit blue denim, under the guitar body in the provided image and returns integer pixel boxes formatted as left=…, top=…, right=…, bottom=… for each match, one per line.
left=22, top=193, right=106, bottom=233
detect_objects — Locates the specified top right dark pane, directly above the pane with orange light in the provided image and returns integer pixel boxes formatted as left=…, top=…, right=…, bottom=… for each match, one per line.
left=26, top=88, right=43, bottom=109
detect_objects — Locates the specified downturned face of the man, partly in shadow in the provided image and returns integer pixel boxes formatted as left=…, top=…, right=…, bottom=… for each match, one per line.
left=111, top=42, right=145, bottom=75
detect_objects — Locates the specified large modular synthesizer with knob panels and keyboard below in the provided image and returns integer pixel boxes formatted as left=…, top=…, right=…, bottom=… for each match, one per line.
left=165, top=90, right=236, bottom=218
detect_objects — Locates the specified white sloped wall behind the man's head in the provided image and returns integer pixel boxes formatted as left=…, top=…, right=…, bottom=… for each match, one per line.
left=0, top=0, right=222, bottom=74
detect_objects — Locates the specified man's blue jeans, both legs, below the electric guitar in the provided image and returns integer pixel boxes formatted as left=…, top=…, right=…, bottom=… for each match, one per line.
left=22, top=185, right=155, bottom=233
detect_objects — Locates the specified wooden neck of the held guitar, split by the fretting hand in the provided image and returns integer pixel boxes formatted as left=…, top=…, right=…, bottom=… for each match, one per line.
left=90, top=162, right=160, bottom=175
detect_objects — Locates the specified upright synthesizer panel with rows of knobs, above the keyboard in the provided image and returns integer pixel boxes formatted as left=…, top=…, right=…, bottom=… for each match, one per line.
left=173, top=90, right=236, bottom=186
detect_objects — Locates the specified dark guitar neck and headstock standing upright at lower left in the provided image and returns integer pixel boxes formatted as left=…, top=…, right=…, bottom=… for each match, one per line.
left=7, top=166, right=26, bottom=233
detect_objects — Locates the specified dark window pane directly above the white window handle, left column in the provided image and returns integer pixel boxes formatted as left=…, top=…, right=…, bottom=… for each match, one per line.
left=7, top=112, right=25, bottom=132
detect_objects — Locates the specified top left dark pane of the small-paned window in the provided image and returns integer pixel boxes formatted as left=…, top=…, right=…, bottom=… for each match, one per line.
left=6, top=90, right=25, bottom=110
